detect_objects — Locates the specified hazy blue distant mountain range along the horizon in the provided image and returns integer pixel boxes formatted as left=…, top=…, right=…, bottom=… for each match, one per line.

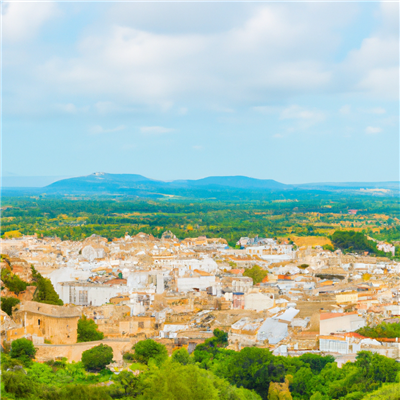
left=30, top=172, right=399, bottom=198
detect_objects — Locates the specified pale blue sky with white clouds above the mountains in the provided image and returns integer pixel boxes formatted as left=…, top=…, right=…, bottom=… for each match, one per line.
left=1, top=1, right=400, bottom=183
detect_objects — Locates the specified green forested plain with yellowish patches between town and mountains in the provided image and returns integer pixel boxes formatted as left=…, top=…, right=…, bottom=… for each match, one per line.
left=0, top=195, right=400, bottom=250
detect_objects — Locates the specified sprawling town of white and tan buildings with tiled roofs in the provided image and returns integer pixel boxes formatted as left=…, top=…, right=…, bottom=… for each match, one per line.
left=0, top=232, right=400, bottom=362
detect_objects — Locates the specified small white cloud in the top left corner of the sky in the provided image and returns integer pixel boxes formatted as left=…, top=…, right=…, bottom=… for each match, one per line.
left=2, top=0, right=58, bottom=42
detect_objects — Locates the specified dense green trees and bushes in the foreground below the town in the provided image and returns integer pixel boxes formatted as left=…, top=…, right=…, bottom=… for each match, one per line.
left=0, top=330, right=400, bottom=400
